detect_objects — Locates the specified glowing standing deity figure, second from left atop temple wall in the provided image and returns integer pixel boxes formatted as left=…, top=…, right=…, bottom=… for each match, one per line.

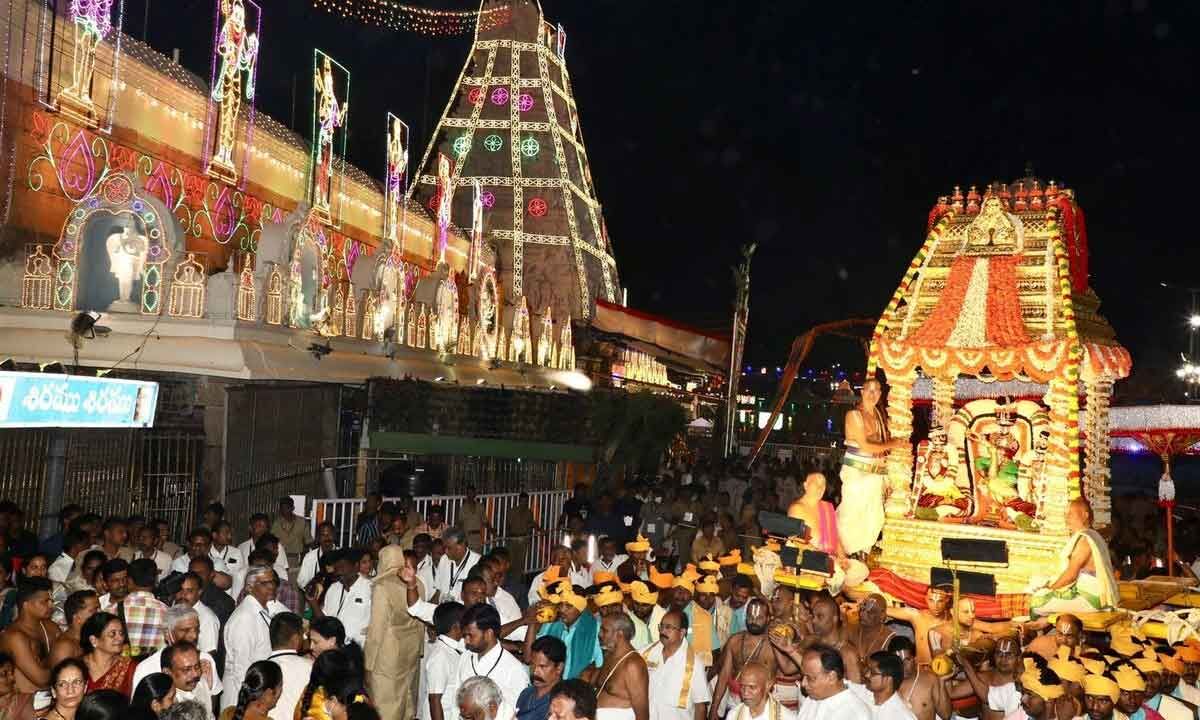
left=212, top=0, right=258, bottom=172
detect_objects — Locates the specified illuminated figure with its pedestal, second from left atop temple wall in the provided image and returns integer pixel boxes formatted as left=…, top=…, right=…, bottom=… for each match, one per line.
left=209, top=0, right=262, bottom=182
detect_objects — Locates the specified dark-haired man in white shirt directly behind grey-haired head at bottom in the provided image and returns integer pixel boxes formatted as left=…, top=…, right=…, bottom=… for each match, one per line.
left=442, top=602, right=529, bottom=720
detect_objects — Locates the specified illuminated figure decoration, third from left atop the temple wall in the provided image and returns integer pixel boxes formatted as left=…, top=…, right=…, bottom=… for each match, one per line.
left=312, top=50, right=350, bottom=224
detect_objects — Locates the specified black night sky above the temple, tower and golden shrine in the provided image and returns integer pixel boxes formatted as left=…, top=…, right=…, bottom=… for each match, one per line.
left=142, top=0, right=1200, bottom=391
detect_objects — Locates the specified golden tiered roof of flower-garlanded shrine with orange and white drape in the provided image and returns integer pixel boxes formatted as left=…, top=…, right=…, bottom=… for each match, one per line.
left=871, top=180, right=1129, bottom=382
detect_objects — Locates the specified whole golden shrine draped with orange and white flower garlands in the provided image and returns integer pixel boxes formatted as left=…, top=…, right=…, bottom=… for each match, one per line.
left=869, top=179, right=1130, bottom=593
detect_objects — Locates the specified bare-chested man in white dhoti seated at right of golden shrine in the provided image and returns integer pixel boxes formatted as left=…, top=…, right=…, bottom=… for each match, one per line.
left=1030, top=498, right=1121, bottom=616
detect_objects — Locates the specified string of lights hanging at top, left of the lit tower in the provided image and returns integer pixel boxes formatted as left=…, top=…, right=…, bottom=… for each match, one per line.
left=312, top=0, right=512, bottom=37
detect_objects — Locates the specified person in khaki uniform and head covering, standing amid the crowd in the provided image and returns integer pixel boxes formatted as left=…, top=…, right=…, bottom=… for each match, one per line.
left=362, top=545, right=425, bottom=720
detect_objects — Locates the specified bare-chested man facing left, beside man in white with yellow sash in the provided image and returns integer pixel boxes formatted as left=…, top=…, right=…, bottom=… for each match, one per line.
left=581, top=613, right=650, bottom=720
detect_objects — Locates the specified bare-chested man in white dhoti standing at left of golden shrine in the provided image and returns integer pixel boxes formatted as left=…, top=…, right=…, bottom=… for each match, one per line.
left=838, top=378, right=908, bottom=556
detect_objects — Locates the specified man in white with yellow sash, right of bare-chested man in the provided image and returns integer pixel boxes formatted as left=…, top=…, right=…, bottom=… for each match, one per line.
left=643, top=611, right=713, bottom=720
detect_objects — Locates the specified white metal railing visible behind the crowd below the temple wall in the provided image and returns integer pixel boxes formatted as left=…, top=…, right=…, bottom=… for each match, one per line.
left=308, top=490, right=571, bottom=572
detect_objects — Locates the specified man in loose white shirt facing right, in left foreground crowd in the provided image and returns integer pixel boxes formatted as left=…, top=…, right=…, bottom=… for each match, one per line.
left=221, top=565, right=287, bottom=709
